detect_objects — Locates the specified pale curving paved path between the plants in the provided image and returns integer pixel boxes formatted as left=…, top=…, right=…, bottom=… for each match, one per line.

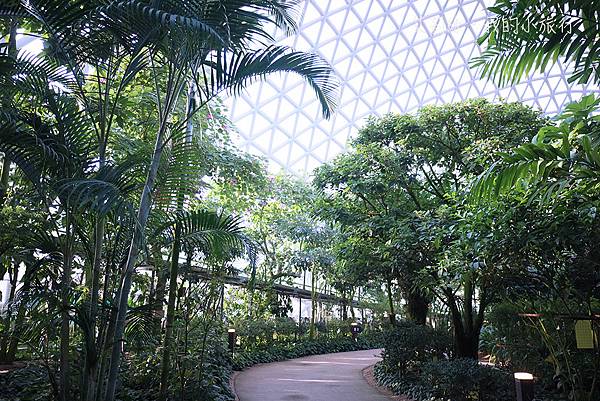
left=235, top=350, right=389, bottom=401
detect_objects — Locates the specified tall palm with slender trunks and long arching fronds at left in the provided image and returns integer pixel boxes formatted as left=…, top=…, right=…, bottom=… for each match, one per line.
left=0, top=0, right=337, bottom=401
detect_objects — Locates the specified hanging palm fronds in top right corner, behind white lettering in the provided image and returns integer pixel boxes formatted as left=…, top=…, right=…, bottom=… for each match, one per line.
left=471, top=0, right=600, bottom=86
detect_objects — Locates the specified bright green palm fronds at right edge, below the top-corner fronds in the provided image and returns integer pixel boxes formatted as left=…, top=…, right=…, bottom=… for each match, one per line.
left=471, top=95, right=600, bottom=203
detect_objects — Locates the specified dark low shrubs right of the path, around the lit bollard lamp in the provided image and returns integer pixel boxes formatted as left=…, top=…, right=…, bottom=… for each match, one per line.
left=374, top=321, right=587, bottom=401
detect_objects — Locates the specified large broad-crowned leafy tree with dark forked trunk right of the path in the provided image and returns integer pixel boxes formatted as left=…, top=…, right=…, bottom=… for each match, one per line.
left=315, top=100, right=545, bottom=358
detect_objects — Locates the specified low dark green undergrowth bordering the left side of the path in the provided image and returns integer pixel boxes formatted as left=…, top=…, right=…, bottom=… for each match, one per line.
left=0, top=319, right=382, bottom=401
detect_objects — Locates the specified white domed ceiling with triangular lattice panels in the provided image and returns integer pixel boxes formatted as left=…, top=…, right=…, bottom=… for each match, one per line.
left=226, top=0, right=586, bottom=175
